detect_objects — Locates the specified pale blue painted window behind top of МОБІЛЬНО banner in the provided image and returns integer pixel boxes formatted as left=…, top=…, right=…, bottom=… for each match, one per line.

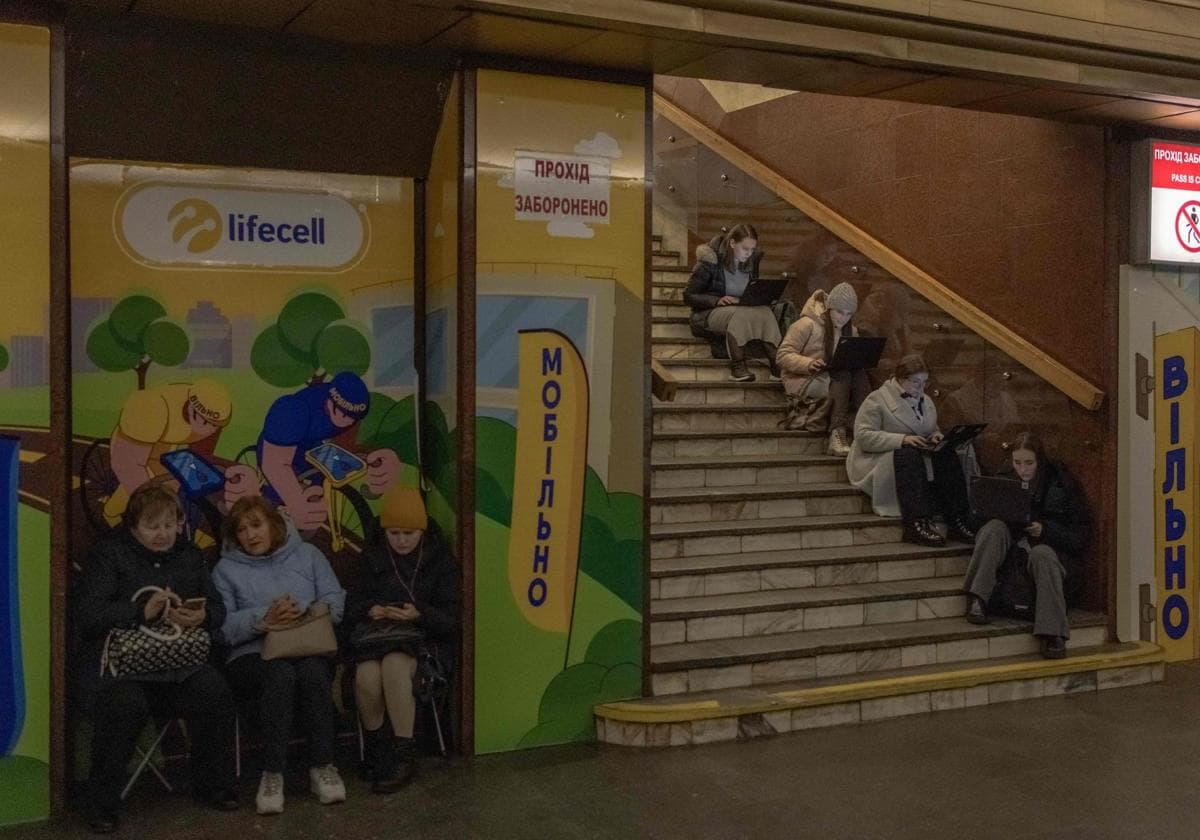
left=475, top=294, right=590, bottom=388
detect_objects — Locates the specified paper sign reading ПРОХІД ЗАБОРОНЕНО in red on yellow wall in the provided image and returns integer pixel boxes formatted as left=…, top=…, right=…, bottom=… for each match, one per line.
left=512, top=150, right=610, bottom=224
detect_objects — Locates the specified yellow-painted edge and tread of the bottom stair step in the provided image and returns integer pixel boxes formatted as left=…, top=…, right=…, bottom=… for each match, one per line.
left=593, top=642, right=1165, bottom=724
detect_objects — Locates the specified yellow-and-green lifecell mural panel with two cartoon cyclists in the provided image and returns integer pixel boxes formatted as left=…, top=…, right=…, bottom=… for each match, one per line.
left=71, top=161, right=420, bottom=590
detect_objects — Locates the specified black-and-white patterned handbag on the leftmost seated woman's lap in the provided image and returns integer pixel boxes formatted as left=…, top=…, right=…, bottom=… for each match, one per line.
left=100, top=587, right=212, bottom=677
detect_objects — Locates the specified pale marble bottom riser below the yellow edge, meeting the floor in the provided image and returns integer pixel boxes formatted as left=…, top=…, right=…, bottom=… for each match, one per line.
left=596, top=662, right=1165, bottom=746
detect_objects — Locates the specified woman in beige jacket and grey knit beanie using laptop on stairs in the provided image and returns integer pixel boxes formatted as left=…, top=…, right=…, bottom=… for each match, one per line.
left=775, top=283, right=871, bottom=457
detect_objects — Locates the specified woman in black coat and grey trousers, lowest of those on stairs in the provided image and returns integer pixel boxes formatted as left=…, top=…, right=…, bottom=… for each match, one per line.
left=962, top=432, right=1091, bottom=659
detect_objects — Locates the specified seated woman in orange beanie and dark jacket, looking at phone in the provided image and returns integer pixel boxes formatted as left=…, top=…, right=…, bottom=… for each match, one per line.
left=343, top=487, right=460, bottom=793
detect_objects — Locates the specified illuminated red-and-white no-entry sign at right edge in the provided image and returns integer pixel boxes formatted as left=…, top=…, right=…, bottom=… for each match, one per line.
left=1150, top=142, right=1200, bottom=263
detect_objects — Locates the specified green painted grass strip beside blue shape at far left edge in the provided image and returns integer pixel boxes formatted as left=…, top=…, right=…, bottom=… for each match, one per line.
left=13, top=505, right=50, bottom=761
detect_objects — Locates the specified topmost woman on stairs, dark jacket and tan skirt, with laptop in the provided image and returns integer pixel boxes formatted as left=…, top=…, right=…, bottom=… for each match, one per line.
left=683, top=222, right=780, bottom=382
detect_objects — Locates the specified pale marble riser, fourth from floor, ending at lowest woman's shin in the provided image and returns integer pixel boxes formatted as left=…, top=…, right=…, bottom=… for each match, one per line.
left=650, top=557, right=968, bottom=601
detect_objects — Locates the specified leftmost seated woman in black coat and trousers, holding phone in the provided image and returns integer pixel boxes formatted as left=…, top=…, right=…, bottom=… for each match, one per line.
left=74, top=485, right=238, bottom=833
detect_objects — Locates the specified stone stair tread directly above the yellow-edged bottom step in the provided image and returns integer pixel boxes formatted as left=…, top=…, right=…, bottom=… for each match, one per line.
left=650, top=610, right=1106, bottom=673
